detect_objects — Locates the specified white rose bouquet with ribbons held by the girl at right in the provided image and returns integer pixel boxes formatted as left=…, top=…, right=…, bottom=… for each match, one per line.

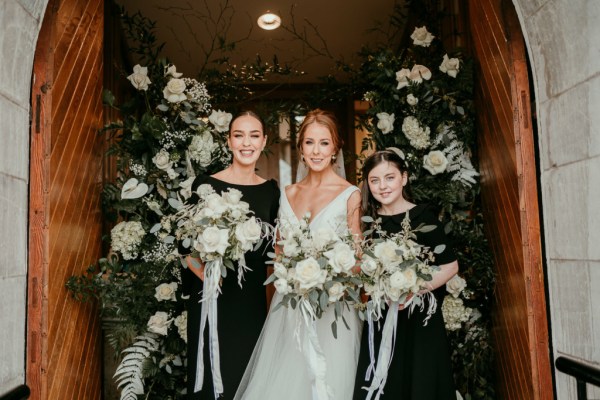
left=360, top=213, right=444, bottom=399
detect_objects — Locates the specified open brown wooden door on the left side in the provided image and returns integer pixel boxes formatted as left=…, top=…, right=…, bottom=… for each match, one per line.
left=27, top=0, right=104, bottom=399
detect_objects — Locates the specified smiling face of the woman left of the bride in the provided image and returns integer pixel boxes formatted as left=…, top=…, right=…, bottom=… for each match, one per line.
left=227, top=115, right=267, bottom=165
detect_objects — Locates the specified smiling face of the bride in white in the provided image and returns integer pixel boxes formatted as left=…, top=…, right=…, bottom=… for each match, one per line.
left=300, top=123, right=337, bottom=172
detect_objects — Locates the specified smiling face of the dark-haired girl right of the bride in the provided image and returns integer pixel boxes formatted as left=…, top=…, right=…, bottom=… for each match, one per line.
left=367, top=161, right=408, bottom=208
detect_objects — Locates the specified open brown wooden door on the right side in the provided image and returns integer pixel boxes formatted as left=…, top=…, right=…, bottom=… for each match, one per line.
left=469, top=0, right=553, bottom=400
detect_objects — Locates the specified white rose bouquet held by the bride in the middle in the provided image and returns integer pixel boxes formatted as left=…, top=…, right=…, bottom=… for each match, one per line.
left=265, top=216, right=361, bottom=337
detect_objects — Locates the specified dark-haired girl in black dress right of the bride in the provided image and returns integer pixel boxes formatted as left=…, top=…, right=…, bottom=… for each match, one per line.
left=354, top=150, right=458, bottom=400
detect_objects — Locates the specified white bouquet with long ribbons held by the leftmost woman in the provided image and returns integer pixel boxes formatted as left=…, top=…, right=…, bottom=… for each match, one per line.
left=170, top=184, right=268, bottom=396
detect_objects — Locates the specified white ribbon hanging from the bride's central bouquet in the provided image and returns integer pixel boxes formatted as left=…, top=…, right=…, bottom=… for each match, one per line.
left=296, top=299, right=333, bottom=400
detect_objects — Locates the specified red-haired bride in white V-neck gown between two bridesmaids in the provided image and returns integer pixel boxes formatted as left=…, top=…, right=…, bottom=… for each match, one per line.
left=235, top=109, right=362, bottom=400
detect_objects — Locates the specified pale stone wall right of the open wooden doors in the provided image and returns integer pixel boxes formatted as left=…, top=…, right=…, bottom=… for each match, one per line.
left=513, top=0, right=600, bottom=400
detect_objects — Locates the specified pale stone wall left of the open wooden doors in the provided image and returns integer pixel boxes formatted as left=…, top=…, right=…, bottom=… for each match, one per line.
left=0, top=0, right=48, bottom=394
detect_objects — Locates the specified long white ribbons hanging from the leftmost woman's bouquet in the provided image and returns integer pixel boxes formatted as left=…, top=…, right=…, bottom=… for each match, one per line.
left=194, top=258, right=223, bottom=399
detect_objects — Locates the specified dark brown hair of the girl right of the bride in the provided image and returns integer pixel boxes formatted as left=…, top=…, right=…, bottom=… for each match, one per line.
left=361, top=150, right=412, bottom=225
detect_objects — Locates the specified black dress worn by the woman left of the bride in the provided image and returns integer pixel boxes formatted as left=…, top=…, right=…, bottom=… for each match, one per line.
left=182, top=176, right=280, bottom=400
